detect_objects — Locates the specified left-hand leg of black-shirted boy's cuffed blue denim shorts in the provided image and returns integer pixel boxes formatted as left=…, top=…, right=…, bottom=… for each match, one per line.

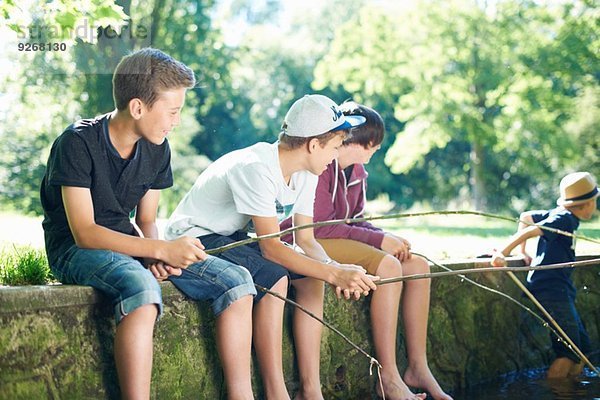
left=51, top=245, right=163, bottom=324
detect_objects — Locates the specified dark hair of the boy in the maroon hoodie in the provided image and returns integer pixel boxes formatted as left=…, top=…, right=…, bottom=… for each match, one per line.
left=340, top=101, right=385, bottom=149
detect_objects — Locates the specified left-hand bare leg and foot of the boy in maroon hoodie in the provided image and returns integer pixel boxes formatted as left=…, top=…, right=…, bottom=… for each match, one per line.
left=371, top=255, right=424, bottom=400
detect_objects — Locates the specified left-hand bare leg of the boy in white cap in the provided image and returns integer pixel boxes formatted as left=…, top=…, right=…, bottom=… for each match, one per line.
left=253, top=278, right=290, bottom=400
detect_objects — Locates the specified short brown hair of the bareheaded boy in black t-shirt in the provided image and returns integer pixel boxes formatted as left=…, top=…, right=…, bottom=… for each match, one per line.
left=113, top=48, right=196, bottom=110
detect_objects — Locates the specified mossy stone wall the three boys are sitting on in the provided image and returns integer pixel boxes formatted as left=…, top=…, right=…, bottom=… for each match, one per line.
left=0, top=261, right=600, bottom=399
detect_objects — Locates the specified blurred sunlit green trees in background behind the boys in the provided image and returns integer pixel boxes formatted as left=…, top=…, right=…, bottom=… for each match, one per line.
left=0, top=0, right=600, bottom=216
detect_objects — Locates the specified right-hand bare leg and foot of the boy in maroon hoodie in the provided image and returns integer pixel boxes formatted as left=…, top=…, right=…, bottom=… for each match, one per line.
left=402, top=256, right=452, bottom=400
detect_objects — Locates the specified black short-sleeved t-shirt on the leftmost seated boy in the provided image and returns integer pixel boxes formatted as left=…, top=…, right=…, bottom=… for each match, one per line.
left=40, top=114, right=173, bottom=265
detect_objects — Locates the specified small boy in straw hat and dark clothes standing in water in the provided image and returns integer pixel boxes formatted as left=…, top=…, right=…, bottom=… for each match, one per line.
left=491, top=172, right=599, bottom=378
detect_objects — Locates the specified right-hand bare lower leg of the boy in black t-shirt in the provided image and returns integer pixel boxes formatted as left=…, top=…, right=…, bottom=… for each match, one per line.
left=217, top=296, right=254, bottom=400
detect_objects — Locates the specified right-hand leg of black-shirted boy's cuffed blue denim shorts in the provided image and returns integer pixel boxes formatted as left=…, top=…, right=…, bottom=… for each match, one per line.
left=169, top=256, right=256, bottom=315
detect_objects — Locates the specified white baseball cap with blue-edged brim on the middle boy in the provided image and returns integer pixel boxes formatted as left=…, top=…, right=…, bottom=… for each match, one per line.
left=281, top=94, right=366, bottom=137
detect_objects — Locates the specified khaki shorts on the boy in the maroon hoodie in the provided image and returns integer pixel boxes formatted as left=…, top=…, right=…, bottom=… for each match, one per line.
left=317, top=239, right=387, bottom=275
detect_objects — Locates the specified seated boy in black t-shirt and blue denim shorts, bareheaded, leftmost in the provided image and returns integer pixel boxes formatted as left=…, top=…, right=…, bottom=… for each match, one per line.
left=41, top=49, right=256, bottom=399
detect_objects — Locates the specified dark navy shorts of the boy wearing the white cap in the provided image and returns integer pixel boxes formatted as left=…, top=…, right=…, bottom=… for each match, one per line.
left=198, top=232, right=289, bottom=303
